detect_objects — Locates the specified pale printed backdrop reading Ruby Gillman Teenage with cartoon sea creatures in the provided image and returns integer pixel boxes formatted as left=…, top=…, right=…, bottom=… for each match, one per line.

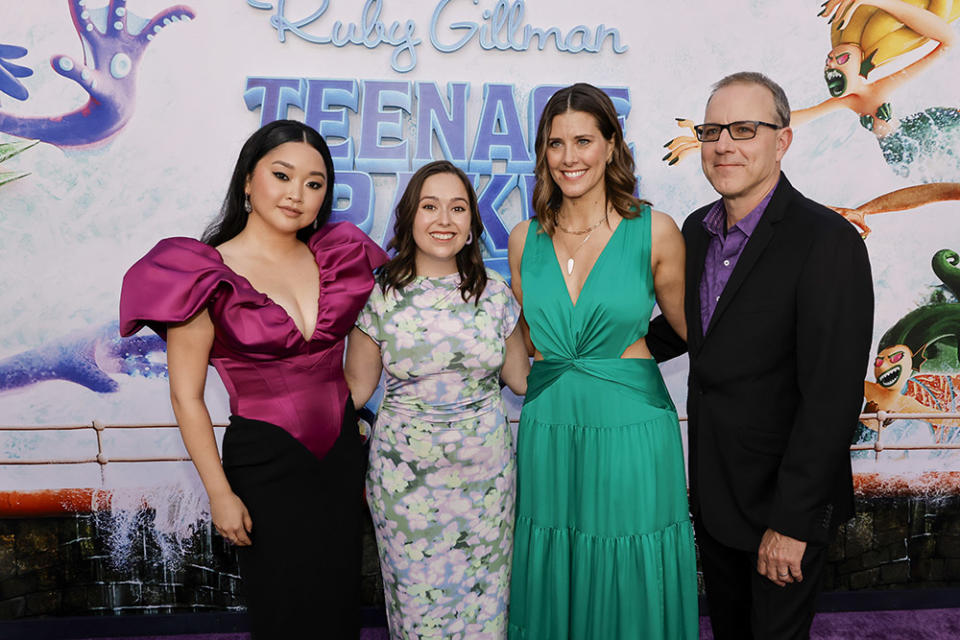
left=0, top=0, right=960, bottom=596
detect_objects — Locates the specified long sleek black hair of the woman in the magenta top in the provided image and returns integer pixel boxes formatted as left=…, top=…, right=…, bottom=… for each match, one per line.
left=200, top=120, right=334, bottom=247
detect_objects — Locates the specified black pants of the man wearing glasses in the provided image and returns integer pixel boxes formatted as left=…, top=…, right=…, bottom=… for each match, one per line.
left=694, top=518, right=827, bottom=640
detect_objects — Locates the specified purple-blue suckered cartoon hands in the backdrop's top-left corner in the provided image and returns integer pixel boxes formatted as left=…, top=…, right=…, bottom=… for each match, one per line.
left=0, top=0, right=195, bottom=147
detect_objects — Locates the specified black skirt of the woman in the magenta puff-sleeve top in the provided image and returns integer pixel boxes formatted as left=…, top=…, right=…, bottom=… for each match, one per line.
left=223, top=399, right=364, bottom=640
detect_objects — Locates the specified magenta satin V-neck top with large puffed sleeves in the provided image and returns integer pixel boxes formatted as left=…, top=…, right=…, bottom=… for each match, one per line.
left=120, top=222, right=387, bottom=458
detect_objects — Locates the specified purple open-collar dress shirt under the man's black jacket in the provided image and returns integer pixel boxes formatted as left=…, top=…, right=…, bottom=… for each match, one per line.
left=700, top=181, right=779, bottom=334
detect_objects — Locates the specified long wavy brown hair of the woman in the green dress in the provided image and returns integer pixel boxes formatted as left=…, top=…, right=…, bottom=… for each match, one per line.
left=533, top=82, right=650, bottom=236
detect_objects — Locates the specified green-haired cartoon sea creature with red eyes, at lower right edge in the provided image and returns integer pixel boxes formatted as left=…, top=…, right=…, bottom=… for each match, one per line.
left=863, top=249, right=960, bottom=442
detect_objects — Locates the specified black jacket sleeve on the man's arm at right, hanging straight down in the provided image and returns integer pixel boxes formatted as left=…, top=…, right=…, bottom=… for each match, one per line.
left=768, top=219, right=873, bottom=540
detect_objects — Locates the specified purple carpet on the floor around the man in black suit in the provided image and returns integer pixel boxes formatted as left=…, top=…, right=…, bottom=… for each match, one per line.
left=696, top=609, right=960, bottom=640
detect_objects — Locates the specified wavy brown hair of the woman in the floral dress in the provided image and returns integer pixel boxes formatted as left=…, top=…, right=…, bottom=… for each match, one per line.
left=379, top=160, right=487, bottom=304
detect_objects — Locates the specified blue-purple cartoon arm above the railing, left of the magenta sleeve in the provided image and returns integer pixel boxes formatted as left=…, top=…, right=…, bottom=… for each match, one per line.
left=0, top=323, right=167, bottom=393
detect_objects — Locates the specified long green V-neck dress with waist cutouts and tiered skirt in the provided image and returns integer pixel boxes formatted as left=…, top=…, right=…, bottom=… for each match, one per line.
left=509, top=207, right=698, bottom=640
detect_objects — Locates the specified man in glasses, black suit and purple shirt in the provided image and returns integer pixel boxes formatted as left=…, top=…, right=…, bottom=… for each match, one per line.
left=647, top=73, right=873, bottom=640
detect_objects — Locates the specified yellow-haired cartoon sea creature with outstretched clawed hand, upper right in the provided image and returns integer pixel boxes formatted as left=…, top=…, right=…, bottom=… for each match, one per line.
left=663, top=0, right=960, bottom=182
